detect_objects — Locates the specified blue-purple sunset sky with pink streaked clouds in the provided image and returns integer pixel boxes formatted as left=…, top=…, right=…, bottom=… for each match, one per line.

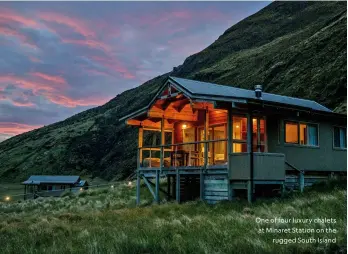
left=0, top=2, right=269, bottom=141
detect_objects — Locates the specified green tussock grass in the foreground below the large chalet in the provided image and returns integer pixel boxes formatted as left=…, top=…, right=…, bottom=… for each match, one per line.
left=0, top=180, right=347, bottom=254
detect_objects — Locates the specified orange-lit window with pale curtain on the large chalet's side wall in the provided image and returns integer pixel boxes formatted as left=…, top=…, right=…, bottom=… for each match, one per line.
left=285, top=122, right=319, bottom=146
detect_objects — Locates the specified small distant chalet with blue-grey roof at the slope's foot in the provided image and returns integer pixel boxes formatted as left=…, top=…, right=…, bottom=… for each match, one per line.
left=22, top=175, right=88, bottom=200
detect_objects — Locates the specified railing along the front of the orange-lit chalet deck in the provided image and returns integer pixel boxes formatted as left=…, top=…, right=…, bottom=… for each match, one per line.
left=138, top=139, right=228, bottom=168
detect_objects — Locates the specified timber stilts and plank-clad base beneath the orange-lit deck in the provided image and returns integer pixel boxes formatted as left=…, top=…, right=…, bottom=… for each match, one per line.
left=137, top=165, right=228, bottom=204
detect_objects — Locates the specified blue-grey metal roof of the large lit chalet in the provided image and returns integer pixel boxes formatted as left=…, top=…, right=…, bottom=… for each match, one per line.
left=169, top=77, right=332, bottom=112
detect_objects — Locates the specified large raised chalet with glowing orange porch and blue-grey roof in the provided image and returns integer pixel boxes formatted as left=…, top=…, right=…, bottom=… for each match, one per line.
left=120, top=77, right=347, bottom=204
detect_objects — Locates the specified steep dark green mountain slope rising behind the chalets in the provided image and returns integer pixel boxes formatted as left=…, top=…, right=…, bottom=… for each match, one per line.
left=0, top=2, right=347, bottom=181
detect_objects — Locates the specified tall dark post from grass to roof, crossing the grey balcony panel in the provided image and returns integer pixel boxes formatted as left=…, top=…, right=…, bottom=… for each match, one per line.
left=247, top=111, right=254, bottom=203
